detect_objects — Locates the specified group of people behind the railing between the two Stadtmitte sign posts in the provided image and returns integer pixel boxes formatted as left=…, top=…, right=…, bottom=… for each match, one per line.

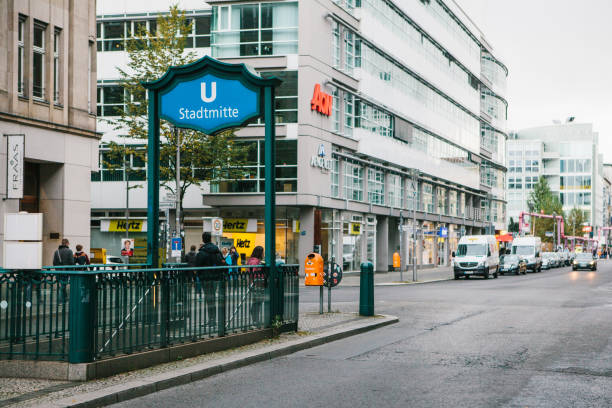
left=185, top=232, right=266, bottom=329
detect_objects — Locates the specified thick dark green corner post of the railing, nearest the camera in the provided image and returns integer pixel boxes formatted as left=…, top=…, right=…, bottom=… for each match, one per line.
left=68, top=272, right=98, bottom=363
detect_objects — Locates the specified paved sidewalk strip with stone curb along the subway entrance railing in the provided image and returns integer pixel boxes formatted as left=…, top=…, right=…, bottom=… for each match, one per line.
left=0, top=312, right=398, bottom=407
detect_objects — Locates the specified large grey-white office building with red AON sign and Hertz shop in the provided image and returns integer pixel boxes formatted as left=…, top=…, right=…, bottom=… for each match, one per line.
left=92, top=0, right=508, bottom=270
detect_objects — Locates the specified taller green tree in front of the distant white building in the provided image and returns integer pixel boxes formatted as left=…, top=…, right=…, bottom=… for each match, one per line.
left=527, top=176, right=564, bottom=242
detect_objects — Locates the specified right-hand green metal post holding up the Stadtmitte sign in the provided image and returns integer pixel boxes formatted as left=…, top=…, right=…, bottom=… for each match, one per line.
left=264, top=86, right=283, bottom=324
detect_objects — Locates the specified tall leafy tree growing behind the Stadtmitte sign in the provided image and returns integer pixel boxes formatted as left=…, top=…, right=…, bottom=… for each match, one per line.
left=108, top=6, right=248, bottom=233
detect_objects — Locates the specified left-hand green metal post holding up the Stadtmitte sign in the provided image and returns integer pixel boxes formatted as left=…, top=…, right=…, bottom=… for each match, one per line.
left=147, top=90, right=159, bottom=268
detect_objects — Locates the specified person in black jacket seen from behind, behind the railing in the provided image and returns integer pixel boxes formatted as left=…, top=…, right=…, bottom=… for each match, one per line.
left=196, top=232, right=225, bottom=330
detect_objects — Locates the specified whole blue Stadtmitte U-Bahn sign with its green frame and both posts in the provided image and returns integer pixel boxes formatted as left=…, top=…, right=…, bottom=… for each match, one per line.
left=142, top=56, right=283, bottom=318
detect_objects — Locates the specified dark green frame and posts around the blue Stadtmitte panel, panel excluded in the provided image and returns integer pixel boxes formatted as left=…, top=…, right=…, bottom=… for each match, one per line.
left=141, top=56, right=284, bottom=316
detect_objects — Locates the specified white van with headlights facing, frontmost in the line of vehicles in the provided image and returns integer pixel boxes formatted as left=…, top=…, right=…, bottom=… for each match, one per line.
left=453, top=235, right=499, bottom=279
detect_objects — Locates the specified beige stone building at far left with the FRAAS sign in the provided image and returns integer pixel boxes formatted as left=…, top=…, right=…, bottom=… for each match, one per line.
left=0, top=0, right=100, bottom=265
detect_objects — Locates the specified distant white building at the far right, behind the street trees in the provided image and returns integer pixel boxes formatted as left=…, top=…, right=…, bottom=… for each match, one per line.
left=507, top=122, right=609, bottom=237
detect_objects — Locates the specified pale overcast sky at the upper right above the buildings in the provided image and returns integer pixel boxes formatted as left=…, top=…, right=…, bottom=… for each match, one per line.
left=455, top=0, right=612, bottom=163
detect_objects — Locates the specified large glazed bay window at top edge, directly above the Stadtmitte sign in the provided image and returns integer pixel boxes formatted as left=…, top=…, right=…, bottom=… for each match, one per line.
left=211, top=2, right=298, bottom=58
